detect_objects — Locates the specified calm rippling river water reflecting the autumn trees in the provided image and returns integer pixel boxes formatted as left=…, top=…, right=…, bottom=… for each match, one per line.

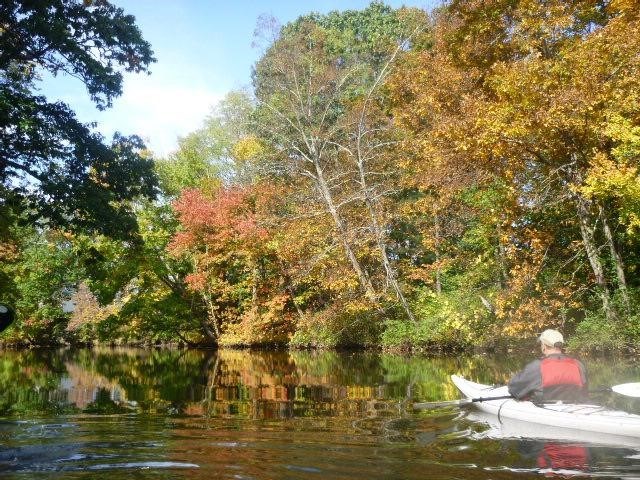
left=0, top=349, right=640, bottom=480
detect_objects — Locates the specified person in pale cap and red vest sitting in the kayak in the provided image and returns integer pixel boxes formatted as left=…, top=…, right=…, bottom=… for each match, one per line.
left=508, top=329, right=587, bottom=403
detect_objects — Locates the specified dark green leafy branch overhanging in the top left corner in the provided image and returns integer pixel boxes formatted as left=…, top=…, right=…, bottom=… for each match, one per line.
left=0, top=0, right=155, bottom=108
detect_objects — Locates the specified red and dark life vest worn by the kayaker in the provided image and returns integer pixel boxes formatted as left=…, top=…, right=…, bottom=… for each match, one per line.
left=540, top=355, right=586, bottom=403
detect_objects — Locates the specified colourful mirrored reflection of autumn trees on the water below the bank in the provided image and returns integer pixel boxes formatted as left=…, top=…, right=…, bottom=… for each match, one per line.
left=0, top=349, right=490, bottom=418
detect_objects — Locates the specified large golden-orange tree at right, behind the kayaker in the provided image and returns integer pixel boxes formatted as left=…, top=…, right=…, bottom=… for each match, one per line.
left=394, top=1, right=638, bottom=340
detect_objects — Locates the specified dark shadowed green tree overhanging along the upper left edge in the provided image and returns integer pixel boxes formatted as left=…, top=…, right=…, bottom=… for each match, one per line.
left=0, top=0, right=157, bottom=236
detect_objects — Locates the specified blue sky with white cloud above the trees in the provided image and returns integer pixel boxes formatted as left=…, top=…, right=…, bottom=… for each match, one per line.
left=41, top=0, right=433, bottom=156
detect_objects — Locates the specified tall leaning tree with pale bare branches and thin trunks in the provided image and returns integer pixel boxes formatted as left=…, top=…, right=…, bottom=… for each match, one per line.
left=254, top=3, right=424, bottom=317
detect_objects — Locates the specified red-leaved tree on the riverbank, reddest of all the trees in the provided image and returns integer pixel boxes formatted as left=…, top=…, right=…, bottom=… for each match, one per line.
left=169, top=184, right=291, bottom=344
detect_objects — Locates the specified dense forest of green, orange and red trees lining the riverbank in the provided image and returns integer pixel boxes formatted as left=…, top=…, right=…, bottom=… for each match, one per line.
left=0, top=0, right=640, bottom=349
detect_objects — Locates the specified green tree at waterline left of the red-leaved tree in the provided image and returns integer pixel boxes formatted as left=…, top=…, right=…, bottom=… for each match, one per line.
left=70, top=202, right=203, bottom=344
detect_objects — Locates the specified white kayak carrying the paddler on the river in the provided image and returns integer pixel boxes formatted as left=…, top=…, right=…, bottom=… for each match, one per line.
left=451, top=375, right=640, bottom=438
